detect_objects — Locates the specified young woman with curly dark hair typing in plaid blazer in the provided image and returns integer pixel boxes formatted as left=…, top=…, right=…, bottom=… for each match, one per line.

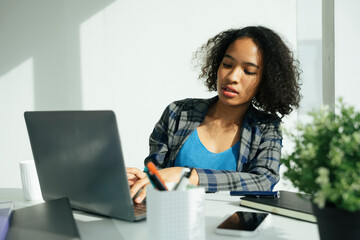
left=127, top=26, right=300, bottom=202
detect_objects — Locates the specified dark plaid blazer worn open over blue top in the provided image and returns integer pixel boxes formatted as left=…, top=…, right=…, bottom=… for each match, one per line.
left=145, top=96, right=282, bottom=192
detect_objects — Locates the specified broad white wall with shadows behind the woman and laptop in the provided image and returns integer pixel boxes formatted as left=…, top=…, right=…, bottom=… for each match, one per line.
left=0, top=0, right=297, bottom=187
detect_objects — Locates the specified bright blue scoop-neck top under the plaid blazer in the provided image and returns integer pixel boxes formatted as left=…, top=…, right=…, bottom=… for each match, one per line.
left=175, top=130, right=240, bottom=171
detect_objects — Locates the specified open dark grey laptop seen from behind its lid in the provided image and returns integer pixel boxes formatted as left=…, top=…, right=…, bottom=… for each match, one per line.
left=24, top=111, right=146, bottom=221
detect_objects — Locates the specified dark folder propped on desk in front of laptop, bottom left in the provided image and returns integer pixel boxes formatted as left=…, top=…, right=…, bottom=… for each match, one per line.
left=6, top=198, right=80, bottom=240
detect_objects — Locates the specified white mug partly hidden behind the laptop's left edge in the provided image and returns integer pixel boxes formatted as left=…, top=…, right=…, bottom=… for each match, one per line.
left=19, top=160, right=42, bottom=201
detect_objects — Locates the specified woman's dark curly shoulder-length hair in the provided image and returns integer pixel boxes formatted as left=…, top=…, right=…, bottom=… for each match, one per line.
left=194, top=26, right=301, bottom=118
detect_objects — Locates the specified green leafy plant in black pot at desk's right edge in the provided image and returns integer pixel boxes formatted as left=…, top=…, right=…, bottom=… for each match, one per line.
left=281, top=98, right=360, bottom=239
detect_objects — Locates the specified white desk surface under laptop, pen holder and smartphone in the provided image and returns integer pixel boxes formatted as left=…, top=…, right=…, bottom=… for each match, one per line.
left=0, top=188, right=319, bottom=240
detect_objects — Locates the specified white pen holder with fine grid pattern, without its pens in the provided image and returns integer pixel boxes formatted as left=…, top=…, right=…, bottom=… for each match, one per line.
left=146, top=186, right=205, bottom=240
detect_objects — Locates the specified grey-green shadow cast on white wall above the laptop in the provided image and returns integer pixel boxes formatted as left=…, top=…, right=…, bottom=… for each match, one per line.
left=0, top=0, right=114, bottom=110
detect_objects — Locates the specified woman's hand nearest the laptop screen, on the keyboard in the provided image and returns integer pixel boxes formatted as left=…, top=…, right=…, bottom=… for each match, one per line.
left=126, top=167, right=150, bottom=203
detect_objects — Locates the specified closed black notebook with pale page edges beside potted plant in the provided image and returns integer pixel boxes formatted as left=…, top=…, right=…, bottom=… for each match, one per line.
left=240, top=191, right=316, bottom=223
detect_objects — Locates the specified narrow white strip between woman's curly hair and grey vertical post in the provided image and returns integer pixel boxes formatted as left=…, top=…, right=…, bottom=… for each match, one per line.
left=275, top=0, right=322, bottom=191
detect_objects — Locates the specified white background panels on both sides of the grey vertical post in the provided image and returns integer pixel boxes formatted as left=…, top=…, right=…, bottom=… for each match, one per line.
left=297, top=0, right=360, bottom=115
